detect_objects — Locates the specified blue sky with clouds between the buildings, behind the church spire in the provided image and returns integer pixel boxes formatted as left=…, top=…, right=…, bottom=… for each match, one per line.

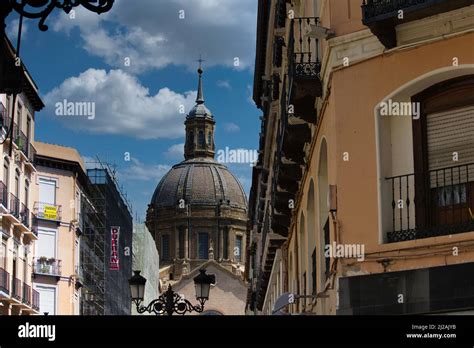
left=7, top=0, right=260, bottom=218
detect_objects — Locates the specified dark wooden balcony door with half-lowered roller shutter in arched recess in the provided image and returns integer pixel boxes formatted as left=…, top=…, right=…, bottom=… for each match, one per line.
left=413, top=75, right=474, bottom=234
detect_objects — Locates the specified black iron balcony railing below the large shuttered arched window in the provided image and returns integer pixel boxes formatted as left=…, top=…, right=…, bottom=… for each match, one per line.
left=386, top=163, right=474, bottom=243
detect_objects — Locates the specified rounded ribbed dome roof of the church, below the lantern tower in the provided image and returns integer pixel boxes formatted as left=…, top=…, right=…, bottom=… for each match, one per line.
left=151, top=158, right=247, bottom=209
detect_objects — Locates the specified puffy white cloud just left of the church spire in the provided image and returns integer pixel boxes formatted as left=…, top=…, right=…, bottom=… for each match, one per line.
left=44, top=69, right=196, bottom=139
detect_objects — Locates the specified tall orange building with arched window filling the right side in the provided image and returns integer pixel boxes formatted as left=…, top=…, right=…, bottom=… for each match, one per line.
left=247, top=0, right=474, bottom=314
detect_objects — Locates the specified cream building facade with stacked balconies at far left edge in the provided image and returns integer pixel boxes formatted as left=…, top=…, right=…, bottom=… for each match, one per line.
left=0, top=36, right=44, bottom=315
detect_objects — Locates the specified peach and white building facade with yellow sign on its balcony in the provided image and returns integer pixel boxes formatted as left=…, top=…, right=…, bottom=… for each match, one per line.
left=33, top=142, right=105, bottom=315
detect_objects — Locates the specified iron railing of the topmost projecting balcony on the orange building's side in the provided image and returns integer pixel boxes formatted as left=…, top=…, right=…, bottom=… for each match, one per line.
left=288, top=17, right=321, bottom=79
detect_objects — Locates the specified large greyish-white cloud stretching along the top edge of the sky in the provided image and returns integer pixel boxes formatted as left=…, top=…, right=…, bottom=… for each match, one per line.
left=52, top=0, right=257, bottom=73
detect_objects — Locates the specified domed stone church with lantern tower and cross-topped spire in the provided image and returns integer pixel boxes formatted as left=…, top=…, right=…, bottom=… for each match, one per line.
left=146, top=68, right=247, bottom=314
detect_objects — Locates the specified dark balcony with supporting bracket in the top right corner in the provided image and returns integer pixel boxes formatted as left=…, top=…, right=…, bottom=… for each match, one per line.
left=362, top=0, right=472, bottom=48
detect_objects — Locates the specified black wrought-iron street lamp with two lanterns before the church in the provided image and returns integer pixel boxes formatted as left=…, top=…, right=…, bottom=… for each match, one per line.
left=128, top=269, right=216, bottom=315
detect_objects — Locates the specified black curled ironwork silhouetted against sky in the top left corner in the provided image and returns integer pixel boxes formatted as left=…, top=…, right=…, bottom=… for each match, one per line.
left=10, top=0, right=115, bottom=31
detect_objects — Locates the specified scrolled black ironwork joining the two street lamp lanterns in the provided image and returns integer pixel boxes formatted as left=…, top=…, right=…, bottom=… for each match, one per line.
left=135, top=285, right=206, bottom=315
